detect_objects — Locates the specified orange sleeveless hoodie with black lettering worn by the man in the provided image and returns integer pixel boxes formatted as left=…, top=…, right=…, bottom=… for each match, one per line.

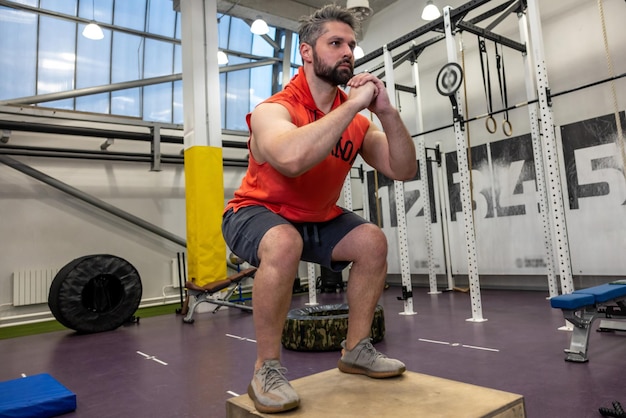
left=225, top=67, right=370, bottom=222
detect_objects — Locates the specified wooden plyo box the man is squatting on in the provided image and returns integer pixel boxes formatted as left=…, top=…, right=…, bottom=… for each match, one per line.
left=226, top=369, right=526, bottom=418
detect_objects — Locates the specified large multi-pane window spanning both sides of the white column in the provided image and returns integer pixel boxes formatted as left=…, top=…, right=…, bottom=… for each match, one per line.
left=0, top=0, right=301, bottom=130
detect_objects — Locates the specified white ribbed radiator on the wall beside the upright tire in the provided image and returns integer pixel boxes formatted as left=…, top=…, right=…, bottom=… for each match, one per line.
left=13, top=268, right=57, bottom=306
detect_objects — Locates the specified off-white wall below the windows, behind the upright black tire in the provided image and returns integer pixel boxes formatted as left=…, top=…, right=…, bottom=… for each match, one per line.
left=0, top=127, right=252, bottom=327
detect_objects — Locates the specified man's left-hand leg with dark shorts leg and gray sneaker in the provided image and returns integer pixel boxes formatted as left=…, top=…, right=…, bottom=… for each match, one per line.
left=222, top=207, right=302, bottom=413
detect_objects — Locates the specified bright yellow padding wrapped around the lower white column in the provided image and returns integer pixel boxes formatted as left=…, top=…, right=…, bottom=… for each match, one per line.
left=185, top=146, right=226, bottom=286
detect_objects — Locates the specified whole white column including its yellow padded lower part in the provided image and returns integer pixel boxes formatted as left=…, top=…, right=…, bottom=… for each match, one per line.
left=180, top=0, right=226, bottom=286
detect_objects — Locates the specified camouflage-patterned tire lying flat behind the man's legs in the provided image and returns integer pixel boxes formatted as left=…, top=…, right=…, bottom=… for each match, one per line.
left=281, top=303, right=385, bottom=351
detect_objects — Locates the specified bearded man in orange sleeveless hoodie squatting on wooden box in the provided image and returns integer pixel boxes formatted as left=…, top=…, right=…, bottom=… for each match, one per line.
left=222, top=5, right=417, bottom=413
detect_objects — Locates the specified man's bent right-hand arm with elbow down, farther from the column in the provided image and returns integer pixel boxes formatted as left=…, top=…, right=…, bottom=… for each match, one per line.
left=348, top=75, right=417, bottom=180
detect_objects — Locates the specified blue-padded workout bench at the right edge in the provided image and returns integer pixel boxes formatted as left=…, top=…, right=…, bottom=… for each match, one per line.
left=550, top=280, right=626, bottom=363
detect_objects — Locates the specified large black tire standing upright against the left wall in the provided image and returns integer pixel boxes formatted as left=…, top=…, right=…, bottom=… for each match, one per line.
left=48, top=254, right=143, bottom=333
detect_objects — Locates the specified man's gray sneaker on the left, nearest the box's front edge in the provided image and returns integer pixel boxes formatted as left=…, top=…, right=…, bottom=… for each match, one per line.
left=248, top=360, right=300, bottom=414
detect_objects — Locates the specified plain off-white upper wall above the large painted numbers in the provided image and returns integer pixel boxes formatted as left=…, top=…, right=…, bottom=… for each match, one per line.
left=359, top=0, right=626, bottom=136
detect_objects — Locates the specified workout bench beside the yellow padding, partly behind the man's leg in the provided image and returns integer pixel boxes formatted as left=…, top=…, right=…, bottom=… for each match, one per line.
left=181, top=267, right=256, bottom=324
